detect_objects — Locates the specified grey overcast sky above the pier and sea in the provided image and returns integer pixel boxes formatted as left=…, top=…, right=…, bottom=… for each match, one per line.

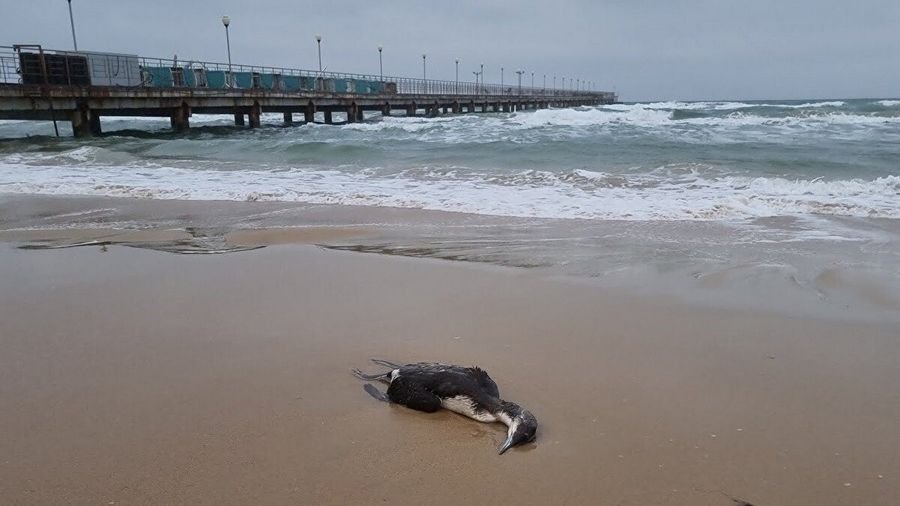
left=0, top=0, right=900, bottom=100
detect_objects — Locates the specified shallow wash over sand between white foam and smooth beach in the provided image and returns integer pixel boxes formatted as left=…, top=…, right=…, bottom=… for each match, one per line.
left=0, top=195, right=900, bottom=324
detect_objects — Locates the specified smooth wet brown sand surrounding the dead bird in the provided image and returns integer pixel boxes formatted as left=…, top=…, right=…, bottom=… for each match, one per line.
left=0, top=236, right=900, bottom=506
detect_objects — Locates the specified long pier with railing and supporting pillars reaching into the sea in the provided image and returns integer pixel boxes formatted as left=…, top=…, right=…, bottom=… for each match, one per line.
left=0, top=45, right=617, bottom=137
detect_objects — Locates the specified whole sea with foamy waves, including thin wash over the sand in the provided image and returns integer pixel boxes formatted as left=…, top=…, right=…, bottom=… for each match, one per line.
left=0, top=99, right=900, bottom=322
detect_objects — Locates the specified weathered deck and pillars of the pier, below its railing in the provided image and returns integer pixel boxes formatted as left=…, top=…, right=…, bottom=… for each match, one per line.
left=0, top=84, right=610, bottom=136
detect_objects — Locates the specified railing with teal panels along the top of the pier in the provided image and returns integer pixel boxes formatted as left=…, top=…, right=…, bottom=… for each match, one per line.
left=0, top=46, right=616, bottom=102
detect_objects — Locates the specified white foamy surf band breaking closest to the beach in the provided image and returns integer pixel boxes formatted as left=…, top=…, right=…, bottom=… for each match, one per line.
left=0, top=160, right=900, bottom=220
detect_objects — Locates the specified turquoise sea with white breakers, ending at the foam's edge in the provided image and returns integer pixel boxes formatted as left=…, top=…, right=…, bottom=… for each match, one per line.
left=0, top=100, right=900, bottom=220
